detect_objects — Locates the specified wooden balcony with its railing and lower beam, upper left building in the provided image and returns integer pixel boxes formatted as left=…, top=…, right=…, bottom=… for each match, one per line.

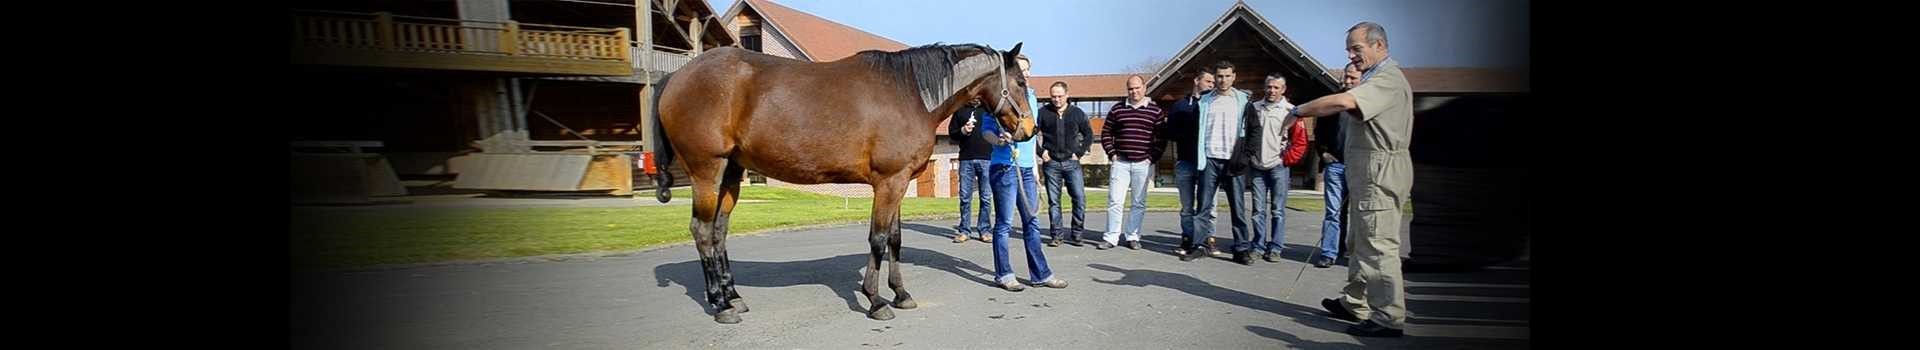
left=292, top=10, right=636, bottom=75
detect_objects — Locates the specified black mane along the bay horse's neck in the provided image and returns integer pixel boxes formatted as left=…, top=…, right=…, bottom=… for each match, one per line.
left=854, top=42, right=1004, bottom=112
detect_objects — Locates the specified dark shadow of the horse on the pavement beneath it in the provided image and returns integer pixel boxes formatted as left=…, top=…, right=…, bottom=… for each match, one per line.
left=653, top=246, right=995, bottom=315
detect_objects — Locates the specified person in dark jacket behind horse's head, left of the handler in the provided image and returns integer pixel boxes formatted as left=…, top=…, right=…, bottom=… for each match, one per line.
left=947, top=98, right=993, bottom=242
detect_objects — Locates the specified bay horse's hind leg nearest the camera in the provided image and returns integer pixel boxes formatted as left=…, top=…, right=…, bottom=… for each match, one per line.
left=687, top=158, right=739, bottom=323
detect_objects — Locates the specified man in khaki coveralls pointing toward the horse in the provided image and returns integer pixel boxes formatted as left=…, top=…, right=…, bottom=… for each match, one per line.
left=1294, top=21, right=1413, bottom=337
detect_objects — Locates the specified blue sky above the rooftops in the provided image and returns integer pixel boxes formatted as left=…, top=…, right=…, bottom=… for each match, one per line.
left=707, top=0, right=1530, bottom=75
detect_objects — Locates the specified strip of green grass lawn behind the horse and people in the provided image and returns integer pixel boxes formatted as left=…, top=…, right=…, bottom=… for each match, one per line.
left=288, top=187, right=1321, bottom=267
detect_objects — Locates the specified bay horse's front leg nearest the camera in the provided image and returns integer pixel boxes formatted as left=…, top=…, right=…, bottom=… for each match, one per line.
left=860, top=175, right=906, bottom=319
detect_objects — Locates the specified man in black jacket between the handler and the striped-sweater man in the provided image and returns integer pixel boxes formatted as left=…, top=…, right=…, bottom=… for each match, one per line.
left=1037, top=81, right=1092, bottom=246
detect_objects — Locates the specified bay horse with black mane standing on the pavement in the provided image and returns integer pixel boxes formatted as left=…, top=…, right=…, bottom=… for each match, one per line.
left=653, top=42, right=1033, bottom=323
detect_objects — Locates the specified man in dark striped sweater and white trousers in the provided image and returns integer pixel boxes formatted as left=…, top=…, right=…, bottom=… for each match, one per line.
left=1100, top=75, right=1165, bottom=250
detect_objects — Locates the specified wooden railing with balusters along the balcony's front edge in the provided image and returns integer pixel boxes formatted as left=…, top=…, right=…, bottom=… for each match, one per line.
left=294, top=10, right=634, bottom=62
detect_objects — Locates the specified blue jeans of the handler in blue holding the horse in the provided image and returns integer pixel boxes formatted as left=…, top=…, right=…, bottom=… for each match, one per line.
left=993, top=163, right=1054, bottom=285
